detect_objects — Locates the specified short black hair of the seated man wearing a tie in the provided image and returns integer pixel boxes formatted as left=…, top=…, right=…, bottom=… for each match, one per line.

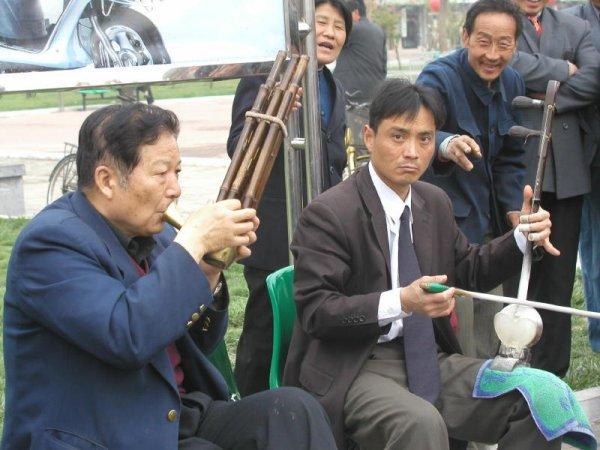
left=369, top=78, right=446, bottom=132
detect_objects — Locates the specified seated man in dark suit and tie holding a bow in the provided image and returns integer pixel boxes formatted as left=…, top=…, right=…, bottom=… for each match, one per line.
left=284, top=80, right=560, bottom=450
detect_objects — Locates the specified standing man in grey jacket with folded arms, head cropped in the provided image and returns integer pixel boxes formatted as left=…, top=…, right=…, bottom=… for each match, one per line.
left=512, top=0, right=600, bottom=376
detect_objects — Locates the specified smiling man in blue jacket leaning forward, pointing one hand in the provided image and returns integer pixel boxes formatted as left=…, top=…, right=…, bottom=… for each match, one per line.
left=417, top=0, right=525, bottom=358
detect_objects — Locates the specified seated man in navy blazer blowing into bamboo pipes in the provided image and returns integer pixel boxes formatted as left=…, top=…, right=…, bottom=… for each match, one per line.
left=2, top=104, right=335, bottom=450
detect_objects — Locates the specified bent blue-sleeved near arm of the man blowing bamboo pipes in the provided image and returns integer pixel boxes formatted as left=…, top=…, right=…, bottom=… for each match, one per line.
left=16, top=222, right=218, bottom=370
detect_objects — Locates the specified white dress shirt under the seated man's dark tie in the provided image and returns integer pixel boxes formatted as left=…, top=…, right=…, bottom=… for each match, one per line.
left=369, top=163, right=527, bottom=343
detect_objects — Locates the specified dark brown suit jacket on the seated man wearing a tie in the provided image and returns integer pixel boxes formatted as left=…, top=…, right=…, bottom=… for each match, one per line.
left=284, top=167, right=522, bottom=448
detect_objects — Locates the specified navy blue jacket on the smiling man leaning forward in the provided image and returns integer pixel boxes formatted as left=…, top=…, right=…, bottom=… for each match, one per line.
left=417, top=49, right=525, bottom=243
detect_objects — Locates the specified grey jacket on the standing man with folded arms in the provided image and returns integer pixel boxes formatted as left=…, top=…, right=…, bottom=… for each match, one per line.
left=512, top=8, right=600, bottom=199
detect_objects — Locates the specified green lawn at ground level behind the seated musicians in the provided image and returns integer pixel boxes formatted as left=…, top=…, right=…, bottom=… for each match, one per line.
left=0, top=219, right=600, bottom=431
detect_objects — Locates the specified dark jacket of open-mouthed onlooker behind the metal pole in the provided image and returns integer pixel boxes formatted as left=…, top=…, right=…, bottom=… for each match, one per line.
left=227, top=67, right=346, bottom=271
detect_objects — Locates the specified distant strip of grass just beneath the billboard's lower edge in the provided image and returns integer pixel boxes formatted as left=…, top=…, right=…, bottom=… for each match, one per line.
left=0, top=79, right=239, bottom=111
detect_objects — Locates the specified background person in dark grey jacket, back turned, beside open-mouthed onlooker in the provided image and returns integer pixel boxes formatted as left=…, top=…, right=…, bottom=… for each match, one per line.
left=333, top=0, right=387, bottom=102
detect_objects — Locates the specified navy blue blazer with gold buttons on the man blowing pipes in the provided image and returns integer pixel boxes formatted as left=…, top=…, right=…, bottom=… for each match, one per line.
left=2, top=192, right=228, bottom=450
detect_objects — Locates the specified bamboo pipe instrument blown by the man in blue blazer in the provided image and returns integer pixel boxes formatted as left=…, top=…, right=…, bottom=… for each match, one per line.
left=165, top=51, right=308, bottom=270
